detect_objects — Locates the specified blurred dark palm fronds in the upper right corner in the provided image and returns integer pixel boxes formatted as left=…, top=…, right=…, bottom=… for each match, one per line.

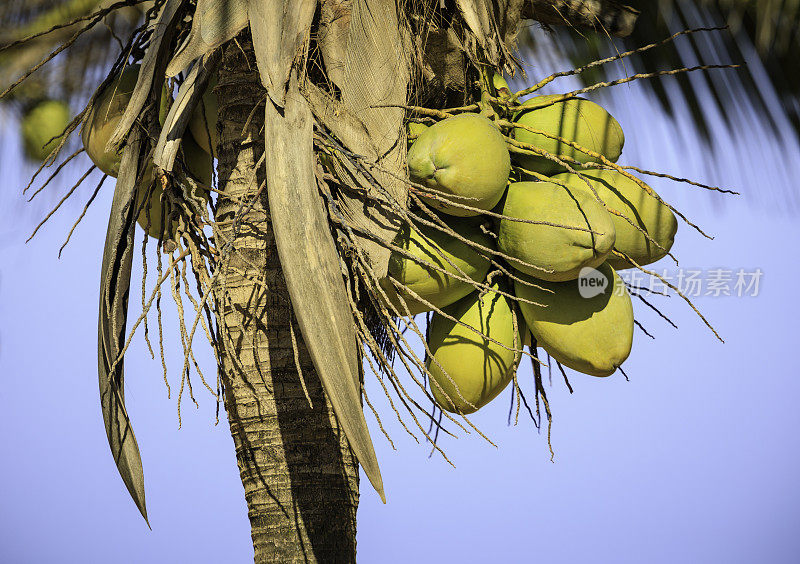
left=536, top=0, right=800, bottom=141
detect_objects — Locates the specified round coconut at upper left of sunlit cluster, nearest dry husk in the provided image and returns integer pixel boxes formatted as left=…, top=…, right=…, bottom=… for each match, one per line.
left=408, top=113, right=511, bottom=216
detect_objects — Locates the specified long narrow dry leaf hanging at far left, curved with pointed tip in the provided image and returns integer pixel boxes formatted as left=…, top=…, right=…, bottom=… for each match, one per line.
left=97, top=128, right=149, bottom=526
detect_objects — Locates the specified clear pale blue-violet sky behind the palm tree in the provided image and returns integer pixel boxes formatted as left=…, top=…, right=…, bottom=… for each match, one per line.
left=0, top=40, right=800, bottom=564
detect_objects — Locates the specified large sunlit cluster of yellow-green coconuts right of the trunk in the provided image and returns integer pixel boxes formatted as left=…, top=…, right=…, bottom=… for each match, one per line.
left=382, top=79, right=677, bottom=414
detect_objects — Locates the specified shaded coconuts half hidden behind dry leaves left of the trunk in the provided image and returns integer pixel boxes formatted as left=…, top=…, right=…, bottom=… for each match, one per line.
left=81, top=65, right=217, bottom=240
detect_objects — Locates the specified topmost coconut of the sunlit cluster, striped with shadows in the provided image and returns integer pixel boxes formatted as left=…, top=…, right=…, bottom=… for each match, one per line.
left=514, top=95, right=625, bottom=175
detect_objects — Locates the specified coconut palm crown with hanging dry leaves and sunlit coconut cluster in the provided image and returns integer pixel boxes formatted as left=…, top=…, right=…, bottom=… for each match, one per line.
left=3, top=0, right=744, bottom=556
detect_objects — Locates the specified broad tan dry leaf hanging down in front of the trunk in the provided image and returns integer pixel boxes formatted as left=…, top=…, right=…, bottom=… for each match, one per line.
left=264, top=77, right=385, bottom=501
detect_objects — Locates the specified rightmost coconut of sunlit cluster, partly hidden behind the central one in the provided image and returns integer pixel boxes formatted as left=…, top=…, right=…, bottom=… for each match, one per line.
left=553, top=169, right=678, bottom=270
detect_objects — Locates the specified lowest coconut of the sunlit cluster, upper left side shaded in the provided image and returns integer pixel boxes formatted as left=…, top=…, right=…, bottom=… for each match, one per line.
left=426, top=284, right=527, bottom=414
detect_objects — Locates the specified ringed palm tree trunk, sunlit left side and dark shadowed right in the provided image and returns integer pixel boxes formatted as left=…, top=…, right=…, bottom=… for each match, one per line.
left=214, top=34, right=358, bottom=563
